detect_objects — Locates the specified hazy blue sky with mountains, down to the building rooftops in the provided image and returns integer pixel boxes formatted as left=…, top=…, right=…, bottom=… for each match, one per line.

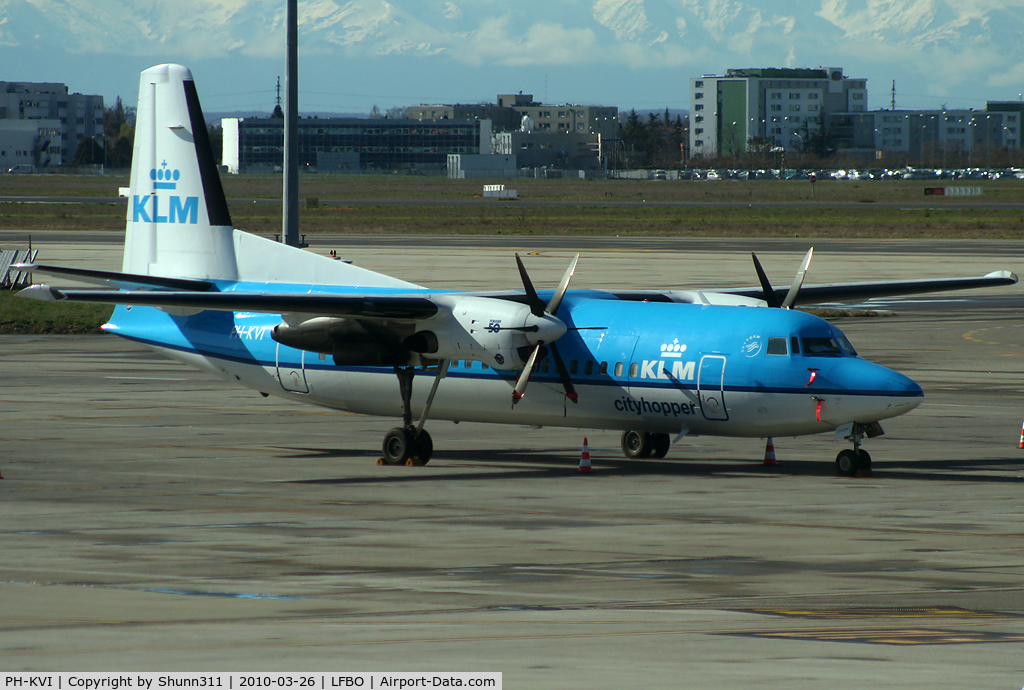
left=0, top=0, right=1024, bottom=113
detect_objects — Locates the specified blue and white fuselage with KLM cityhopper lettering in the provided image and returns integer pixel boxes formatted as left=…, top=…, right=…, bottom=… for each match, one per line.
left=109, top=286, right=924, bottom=437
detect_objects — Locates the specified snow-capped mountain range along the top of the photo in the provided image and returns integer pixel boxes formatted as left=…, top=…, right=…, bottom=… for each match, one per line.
left=0, top=0, right=1024, bottom=109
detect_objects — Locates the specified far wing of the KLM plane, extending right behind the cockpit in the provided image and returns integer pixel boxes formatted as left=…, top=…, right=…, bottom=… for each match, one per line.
left=714, top=270, right=1017, bottom=304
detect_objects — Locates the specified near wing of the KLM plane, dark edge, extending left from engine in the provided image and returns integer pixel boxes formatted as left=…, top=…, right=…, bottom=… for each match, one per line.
left=18, top=285, right=438, bottom=321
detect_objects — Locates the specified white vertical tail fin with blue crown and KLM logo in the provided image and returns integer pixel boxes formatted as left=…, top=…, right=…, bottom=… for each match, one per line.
left=122, top=64, right=416, bottom=288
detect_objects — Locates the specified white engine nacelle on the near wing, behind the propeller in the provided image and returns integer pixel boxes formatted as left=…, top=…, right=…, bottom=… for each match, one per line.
left=403, top=295, right=565, bottom=370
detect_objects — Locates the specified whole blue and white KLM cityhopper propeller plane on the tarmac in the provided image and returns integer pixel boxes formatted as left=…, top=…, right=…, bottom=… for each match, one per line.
left=22, top=64, right=1017, bottom=475
